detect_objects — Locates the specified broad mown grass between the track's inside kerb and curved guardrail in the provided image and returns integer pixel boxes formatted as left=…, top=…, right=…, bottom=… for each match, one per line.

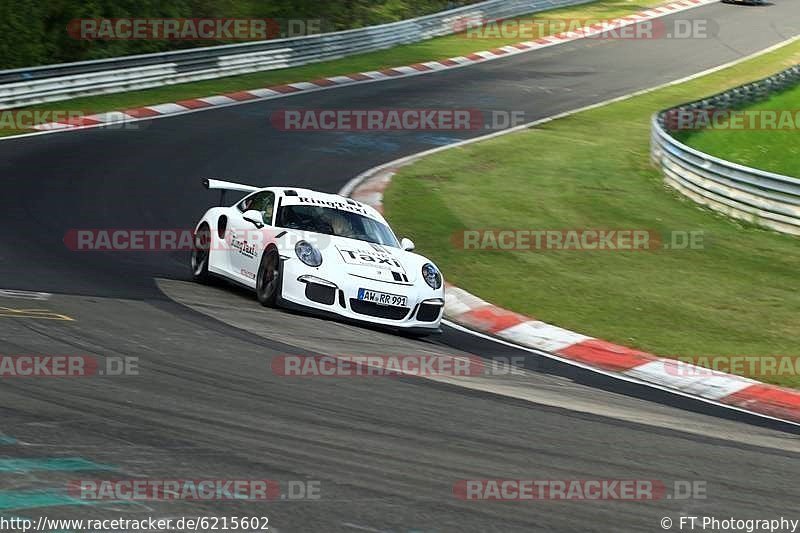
left=385, top=42, right=800, bottom=387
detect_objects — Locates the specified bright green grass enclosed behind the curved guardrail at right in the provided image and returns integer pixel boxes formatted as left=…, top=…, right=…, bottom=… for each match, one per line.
left=679, top=86, right=800, bottom=177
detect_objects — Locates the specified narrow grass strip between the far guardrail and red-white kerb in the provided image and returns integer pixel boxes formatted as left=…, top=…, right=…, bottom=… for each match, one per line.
left=0, top=0, right=666, bottom=136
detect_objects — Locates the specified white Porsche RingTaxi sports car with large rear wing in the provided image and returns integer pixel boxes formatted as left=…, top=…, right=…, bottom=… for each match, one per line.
left=191, top=179, right=444, bottom=335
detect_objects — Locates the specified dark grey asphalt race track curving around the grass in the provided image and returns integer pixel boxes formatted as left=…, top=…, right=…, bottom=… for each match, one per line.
left=0, top=0, right=800, bottom=533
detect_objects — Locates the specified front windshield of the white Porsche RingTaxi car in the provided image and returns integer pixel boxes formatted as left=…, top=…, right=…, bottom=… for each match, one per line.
left=276, top=205, right=400, bottom=248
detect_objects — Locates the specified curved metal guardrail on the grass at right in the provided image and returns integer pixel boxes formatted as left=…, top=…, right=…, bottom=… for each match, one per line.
left=650, top=65, right=800, bottom=235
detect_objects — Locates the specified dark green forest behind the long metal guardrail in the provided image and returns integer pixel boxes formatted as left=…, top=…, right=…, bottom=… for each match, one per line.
left=0, top=0, right=477, bottom=69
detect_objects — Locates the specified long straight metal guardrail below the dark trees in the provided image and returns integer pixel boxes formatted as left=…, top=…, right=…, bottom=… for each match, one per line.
left=0, top=0, right=591, bottom=109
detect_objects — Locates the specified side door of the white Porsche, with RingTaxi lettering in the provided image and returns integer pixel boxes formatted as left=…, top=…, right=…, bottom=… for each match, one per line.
left=228, top=191, right=275, bottom=287
